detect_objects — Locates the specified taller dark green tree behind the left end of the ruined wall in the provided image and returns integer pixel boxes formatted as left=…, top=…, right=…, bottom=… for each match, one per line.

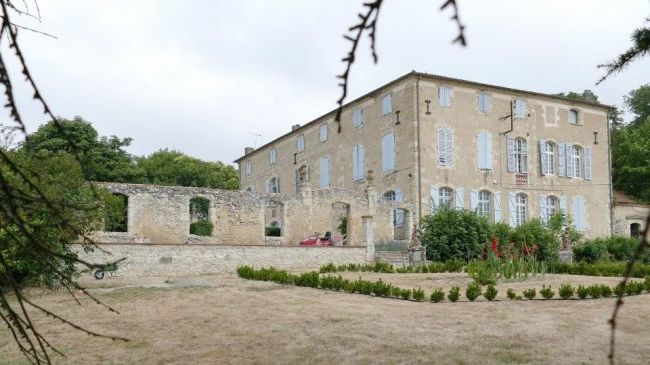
left=24, top=116, right=141, bottom=182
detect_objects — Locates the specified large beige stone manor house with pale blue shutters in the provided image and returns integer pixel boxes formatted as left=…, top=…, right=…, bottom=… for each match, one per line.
left=235, top=71, right=613, bottom=238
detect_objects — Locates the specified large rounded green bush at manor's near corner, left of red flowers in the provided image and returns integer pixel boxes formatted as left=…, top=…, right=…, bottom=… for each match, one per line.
left=420, top=209, right=490, bottom=261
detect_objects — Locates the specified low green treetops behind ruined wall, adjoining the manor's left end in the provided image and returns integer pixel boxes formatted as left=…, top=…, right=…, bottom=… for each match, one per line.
left=137, top=149, right=239, bottom=189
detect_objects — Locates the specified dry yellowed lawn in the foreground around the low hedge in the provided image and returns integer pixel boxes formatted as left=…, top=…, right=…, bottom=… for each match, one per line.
left=0, top=273, right=650, bottom=364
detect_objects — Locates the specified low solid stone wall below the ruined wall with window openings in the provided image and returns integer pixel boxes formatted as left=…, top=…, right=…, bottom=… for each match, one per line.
left=73, top=244, right=366, bottom=277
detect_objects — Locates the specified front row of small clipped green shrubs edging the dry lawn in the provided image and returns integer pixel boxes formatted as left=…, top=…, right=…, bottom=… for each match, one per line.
left=237, top=266, right=650, bottom=303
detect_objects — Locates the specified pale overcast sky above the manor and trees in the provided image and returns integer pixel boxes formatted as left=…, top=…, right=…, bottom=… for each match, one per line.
left=3, top=0, right=650, bottom=163
